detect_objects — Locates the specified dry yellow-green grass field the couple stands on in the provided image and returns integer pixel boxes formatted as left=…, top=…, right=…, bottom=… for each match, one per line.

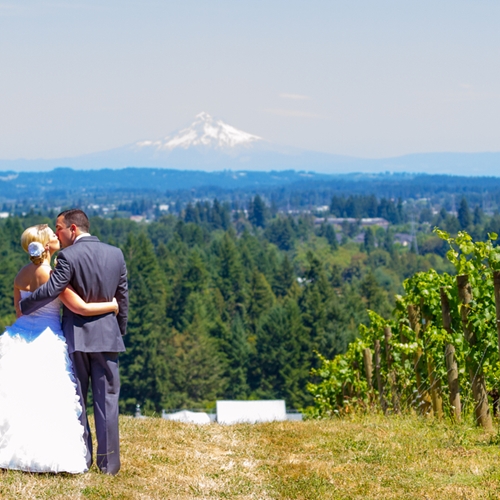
left=0, top=416, right=500, bottom=500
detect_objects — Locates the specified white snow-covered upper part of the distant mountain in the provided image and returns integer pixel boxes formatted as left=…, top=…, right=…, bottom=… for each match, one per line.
left=135, top=111, right=262, bottom=151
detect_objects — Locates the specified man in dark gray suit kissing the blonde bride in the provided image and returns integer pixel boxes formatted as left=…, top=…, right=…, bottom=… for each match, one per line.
left=20, top=209, right=128, bottom=475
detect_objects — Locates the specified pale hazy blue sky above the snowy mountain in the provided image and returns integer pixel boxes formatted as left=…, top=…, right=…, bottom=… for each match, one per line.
left=0, top=0, right=500, bottom=159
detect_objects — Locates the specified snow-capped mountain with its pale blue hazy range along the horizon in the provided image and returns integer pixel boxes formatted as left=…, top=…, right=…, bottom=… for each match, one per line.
left=0, top=112, right=500, bottom=176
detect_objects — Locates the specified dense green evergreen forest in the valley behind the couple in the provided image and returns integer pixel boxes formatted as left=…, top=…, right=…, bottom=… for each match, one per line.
left=0, top=195, right=500, bottom=414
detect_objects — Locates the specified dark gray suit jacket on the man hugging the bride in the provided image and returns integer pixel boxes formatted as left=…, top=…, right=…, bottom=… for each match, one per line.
left=20, top=236, right=128, bottom=353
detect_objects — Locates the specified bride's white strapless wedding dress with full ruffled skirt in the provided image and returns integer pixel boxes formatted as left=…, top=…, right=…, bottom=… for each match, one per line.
left=0, top=292, right=87, bottom=473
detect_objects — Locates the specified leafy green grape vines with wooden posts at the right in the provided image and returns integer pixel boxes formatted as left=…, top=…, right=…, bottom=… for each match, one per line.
left=307, top=228, right=500, bottom=427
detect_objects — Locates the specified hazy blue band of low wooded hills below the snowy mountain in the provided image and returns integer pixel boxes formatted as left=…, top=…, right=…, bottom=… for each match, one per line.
left=0, top=168, right=500, bottom=211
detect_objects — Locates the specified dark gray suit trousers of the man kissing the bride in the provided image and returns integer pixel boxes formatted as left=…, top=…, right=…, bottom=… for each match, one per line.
left=70, top=351, right=120, bottom=475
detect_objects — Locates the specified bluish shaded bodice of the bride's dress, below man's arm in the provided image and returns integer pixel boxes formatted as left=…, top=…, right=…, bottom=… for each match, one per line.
left=7, top=290, right=63, bottom=340
